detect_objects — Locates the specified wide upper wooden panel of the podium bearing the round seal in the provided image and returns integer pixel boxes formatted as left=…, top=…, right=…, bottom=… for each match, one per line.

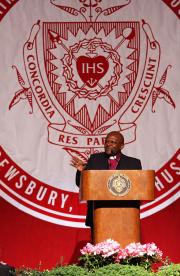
left=80, top=170, right=155, bottom=200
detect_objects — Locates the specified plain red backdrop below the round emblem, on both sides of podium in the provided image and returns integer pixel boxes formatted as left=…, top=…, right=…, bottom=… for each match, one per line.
left=0, top=199, right=180, bottom=268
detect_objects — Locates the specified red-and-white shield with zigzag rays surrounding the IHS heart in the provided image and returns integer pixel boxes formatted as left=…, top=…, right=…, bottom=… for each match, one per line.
left=44, top=22, right=139, bottom=133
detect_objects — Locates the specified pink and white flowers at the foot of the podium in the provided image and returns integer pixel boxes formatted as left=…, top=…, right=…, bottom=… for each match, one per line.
left=79, top=239, right=163, bottom=271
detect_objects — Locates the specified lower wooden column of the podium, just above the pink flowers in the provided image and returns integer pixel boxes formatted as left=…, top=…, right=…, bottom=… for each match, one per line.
left=93, top=202, right=140, bottom=248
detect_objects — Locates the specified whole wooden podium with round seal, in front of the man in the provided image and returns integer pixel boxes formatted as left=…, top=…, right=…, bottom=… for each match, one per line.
left=80, top=170, right=155, bottom=247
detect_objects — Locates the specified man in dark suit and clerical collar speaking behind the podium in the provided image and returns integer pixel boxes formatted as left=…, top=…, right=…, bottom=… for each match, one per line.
left=71, top=131, right=142, bottom=229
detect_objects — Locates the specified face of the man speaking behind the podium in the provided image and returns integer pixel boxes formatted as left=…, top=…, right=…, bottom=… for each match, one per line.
left=104, top=134, right=124, bottom=155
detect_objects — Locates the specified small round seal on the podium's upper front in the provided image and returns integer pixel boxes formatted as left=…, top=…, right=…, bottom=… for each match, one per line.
left=107, top=173, right=131, bottom=196
